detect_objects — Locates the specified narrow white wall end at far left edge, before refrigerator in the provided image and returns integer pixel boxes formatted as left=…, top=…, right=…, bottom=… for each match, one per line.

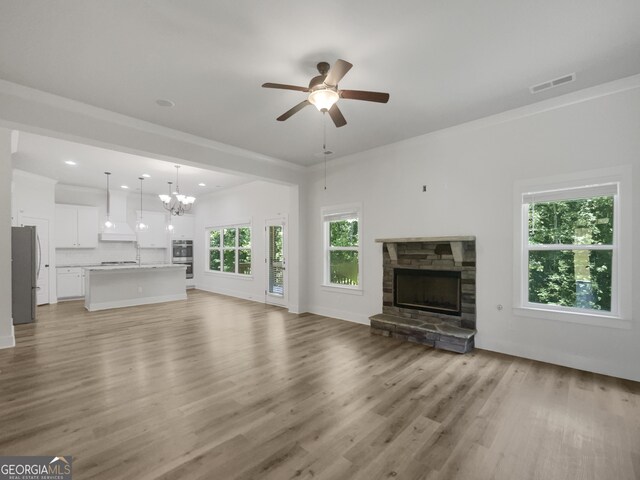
left=0, top=128, right=15, bottom=348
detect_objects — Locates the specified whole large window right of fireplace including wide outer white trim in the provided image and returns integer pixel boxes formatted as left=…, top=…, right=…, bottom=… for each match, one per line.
left=513, top=166, right=634, bottom=329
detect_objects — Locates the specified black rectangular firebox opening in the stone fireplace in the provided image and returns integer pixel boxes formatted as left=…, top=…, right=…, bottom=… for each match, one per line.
left=393, top=268, right=462, bottom=316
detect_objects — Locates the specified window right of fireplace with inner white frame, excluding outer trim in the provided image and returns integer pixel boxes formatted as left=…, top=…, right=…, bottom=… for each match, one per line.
left=522, top=182, right=619, bottom=316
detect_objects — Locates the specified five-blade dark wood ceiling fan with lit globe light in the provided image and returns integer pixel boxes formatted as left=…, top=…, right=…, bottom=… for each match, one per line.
left=262, top=60, right=389, bottom=127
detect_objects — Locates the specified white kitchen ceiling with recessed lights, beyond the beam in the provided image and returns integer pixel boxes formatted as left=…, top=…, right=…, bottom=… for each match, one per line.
left=12, top=132, right=252, bottom=198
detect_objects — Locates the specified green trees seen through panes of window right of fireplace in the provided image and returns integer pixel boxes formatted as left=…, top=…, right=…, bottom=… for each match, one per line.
left=528, top=196, right=615, bottom=312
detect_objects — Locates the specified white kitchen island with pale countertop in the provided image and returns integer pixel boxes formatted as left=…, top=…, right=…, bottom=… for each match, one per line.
left=84, top=264, right=187, bottom=312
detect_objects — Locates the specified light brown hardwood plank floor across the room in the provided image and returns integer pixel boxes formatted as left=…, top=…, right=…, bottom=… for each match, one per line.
left=0, top=291, right=640, bottom=480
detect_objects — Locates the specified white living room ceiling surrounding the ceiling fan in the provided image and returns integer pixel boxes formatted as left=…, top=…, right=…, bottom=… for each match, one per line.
left=0, top=0, right=640, bottom=165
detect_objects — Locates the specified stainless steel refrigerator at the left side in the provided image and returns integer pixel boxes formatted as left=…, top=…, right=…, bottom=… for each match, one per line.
left=11, top=227, right=38, bottom=325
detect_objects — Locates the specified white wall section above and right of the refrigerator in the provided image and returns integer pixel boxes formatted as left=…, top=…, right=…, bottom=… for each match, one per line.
left=11, top=169, right=58, bottom=303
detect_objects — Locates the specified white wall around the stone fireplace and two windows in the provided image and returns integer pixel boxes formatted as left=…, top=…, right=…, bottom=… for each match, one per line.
left=306, top=83, right=640, bottom=380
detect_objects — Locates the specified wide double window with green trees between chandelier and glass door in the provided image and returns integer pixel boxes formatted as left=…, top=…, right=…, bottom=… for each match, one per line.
left=207, top=225, right=251, bottom=275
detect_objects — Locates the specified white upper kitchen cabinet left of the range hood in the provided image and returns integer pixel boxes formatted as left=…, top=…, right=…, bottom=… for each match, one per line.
left=55, top=204, right=98, bottom=248
